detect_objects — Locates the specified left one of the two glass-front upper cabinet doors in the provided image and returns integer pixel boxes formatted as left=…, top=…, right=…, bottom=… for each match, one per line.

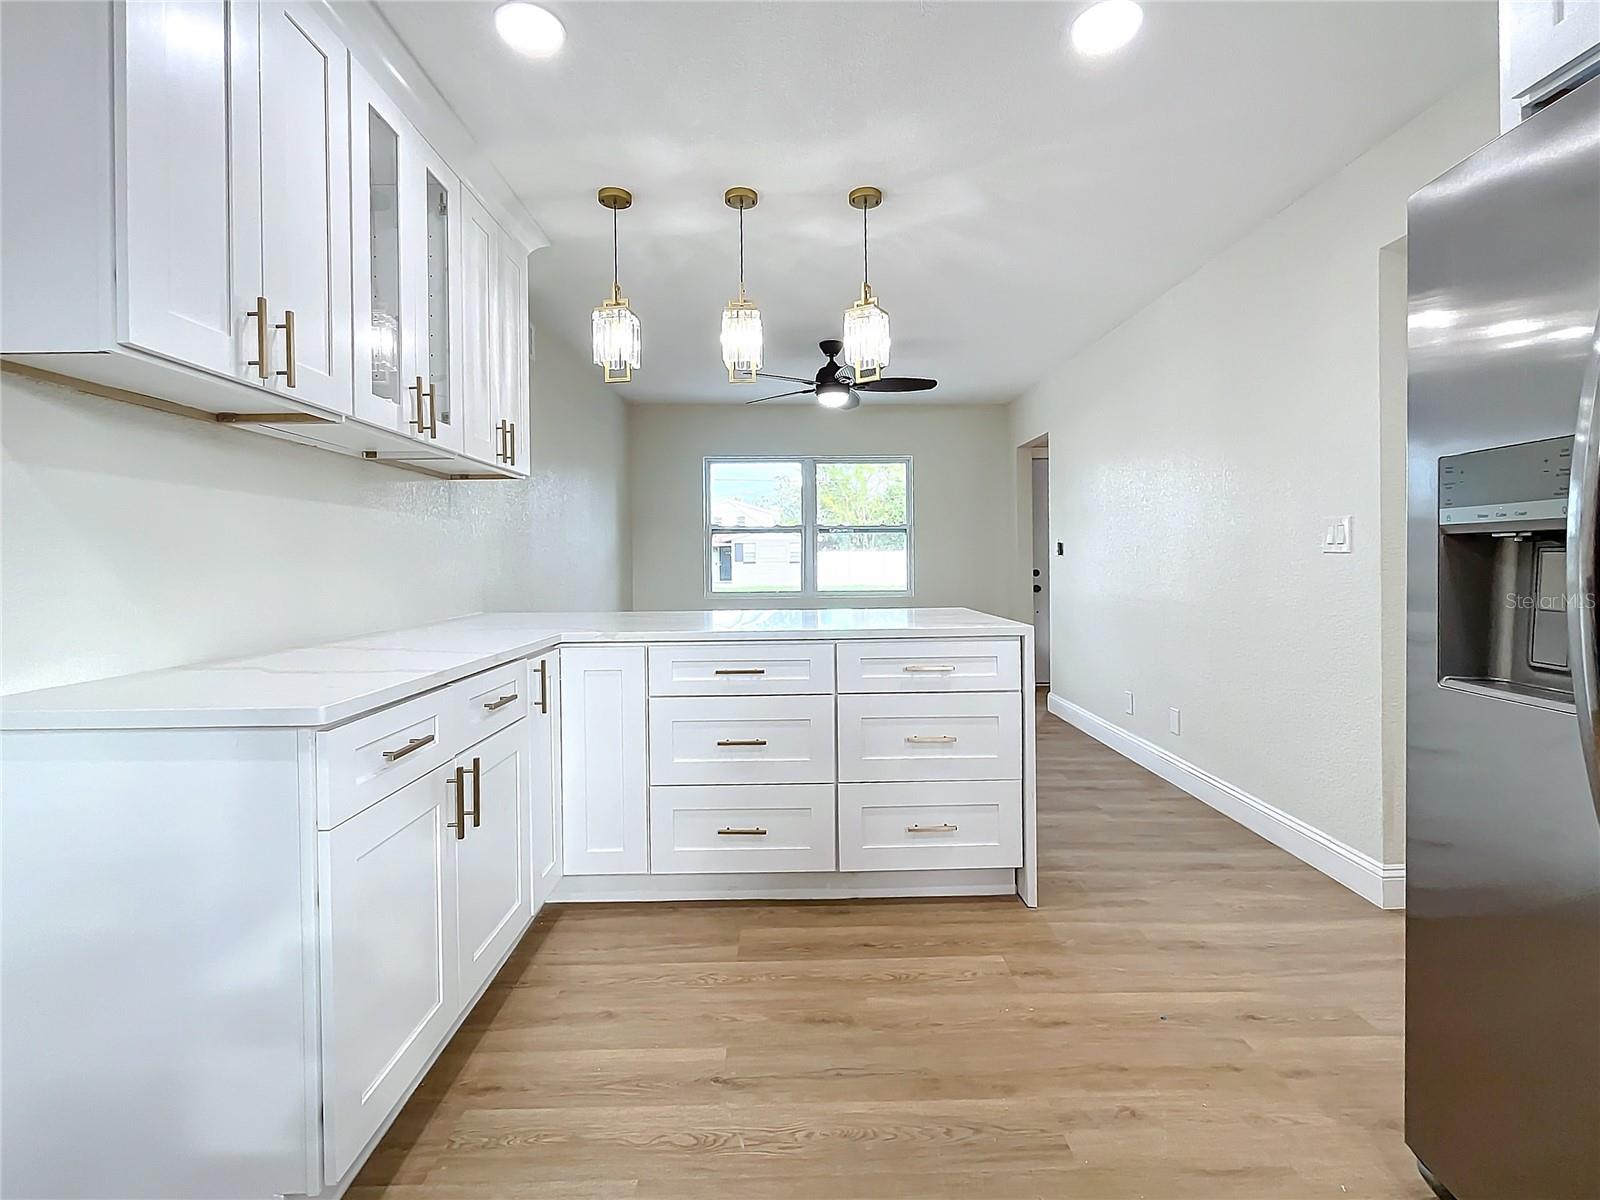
left=350, top=62, right=412, bottom=434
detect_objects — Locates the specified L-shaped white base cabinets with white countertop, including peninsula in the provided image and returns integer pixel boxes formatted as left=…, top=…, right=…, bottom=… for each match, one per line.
left=3, top=608, right=1037, bottom=1197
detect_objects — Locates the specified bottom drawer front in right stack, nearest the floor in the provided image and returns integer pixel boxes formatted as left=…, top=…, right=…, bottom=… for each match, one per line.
left=838, top=779, right=1022, bottom=870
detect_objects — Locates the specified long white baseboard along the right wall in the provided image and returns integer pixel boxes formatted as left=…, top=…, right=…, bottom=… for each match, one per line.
left=1046, top=693, right=1405, bottom=909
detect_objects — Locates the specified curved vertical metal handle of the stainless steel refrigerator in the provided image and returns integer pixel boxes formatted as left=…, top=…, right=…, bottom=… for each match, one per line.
left=1566, top=310, right=1600, bottom=819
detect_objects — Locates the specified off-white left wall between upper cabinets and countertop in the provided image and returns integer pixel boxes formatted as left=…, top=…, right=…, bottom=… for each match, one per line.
left=0, top=339, right=629, bottom=691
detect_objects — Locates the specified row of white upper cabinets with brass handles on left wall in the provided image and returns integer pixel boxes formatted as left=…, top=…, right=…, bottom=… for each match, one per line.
left=0, top=0, right=533, bottom=478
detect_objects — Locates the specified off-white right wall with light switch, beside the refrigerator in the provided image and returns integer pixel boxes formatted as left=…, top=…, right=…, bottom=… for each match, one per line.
left=1011, top=77, right=1496, bottom=862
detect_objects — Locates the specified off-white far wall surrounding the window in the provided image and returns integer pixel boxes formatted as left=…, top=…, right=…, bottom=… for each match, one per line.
left=627, top=400, right=1016, bottom=616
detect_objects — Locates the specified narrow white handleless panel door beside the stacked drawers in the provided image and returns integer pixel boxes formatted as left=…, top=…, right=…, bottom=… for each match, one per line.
left=562, top=646, right=650, bottom=875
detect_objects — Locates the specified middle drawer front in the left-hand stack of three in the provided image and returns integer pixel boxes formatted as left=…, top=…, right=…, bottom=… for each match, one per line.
left=650, top=696, right=834, bottom=786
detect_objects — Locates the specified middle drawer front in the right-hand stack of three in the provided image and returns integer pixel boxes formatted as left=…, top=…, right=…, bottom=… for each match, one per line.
left=838, top=693, right=1022, bottom=784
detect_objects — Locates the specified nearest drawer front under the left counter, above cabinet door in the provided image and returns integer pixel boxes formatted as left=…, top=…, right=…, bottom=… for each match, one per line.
left=314, top=688, right=459, bottom=829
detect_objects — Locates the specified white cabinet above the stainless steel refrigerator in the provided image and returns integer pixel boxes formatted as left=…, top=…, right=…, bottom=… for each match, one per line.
left=1499, top=0, right=1600, bottom=128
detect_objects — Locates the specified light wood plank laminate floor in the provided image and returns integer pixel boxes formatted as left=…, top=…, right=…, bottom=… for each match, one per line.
left=349, top=694, right=1430, bottom=1200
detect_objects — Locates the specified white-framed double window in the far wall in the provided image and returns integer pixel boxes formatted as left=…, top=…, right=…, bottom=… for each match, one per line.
left=706, top=458, right=912, bottom=595
